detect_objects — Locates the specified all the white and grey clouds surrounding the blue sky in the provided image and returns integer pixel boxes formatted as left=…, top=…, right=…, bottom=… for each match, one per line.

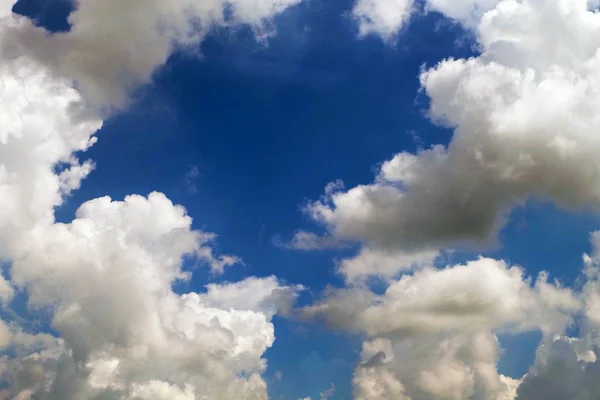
left=5, top=0, right=600, bottom=400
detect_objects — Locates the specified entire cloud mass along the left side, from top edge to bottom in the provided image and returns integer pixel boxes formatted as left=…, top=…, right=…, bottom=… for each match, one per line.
left=0, top=1, right=300, bottom=400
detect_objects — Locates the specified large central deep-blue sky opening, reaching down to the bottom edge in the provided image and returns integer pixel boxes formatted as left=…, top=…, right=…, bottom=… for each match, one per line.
left=52, top=2, right=474, bottom=399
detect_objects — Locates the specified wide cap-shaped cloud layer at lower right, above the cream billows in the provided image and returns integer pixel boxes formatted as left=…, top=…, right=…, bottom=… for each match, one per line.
left=304, top=258, right=581, bottom=337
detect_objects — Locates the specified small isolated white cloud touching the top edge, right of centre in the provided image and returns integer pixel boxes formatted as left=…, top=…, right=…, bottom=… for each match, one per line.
left=352, top=0, right=414, bottom=39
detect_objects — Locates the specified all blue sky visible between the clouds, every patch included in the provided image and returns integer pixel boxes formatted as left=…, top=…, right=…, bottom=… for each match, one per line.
left=0, top=0, right=600, bottom=400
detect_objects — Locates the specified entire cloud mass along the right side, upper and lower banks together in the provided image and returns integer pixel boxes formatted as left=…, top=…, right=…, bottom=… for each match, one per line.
left=303, top=0, right=600, bottom=400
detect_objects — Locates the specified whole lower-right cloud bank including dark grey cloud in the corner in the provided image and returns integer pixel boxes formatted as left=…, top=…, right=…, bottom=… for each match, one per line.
left=303, top=232, right=600, bottom=400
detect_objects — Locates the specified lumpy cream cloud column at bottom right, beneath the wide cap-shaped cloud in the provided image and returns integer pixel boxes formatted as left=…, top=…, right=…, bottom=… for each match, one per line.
left=353, top=333, right=517, bottom=400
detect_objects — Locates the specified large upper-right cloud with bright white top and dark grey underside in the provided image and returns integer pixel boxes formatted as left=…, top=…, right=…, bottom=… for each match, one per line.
left=305, top=0, right=600, bottom=282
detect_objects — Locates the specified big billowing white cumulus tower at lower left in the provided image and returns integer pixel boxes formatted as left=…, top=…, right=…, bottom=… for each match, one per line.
left=0, top=189, right=295, bottom=399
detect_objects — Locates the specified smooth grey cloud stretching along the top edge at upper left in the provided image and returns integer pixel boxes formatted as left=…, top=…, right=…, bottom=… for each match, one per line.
left=0, top=0, right=299, bottom=106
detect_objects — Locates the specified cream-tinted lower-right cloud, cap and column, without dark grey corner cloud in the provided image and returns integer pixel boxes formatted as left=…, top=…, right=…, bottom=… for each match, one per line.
left=303, top=258, right=585, bottom=400
